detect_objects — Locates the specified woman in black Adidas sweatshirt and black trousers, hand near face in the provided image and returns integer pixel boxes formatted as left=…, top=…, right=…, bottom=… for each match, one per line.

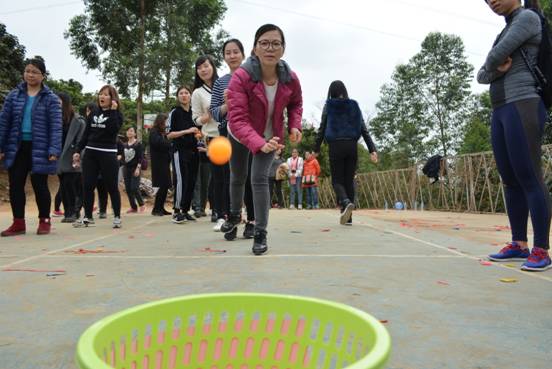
left=73, top=85, right=123, bottom=228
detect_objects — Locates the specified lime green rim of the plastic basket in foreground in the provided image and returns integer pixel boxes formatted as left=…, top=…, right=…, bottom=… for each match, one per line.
left=75, top=292, right=391, bottom=369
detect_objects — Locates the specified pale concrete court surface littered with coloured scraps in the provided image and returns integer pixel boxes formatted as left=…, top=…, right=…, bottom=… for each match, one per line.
left=0, top=210, right=552, bottom=369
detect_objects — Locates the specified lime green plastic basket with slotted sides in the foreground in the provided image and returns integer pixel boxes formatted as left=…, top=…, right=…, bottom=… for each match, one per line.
left=76, top=293, right=391, bottom=369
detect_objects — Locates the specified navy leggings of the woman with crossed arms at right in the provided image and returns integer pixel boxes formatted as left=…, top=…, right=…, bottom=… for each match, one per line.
left=491, top=98, right=551, bottom=249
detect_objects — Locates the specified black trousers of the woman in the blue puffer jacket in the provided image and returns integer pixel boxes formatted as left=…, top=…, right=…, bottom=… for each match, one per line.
left=8, top=141, right=52, bottom=219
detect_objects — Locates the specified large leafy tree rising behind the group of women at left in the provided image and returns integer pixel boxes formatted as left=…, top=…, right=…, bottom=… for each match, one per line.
left=65, top=0, right=226, bottom=136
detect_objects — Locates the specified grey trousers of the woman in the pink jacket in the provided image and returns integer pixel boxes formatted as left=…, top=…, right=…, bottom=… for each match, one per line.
left=229, top=136, right=274, bottom=231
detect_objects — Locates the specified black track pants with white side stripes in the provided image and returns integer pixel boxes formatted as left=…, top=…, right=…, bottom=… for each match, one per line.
left=172, top=150, right=199, bottom=213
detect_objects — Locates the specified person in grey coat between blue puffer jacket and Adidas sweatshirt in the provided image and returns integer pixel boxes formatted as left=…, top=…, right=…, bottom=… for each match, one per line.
left=57, top=92, right=86, bottom=223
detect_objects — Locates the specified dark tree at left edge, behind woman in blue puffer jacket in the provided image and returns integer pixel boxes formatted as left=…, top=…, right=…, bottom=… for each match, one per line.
left=0, top=23, right=25, bottom=103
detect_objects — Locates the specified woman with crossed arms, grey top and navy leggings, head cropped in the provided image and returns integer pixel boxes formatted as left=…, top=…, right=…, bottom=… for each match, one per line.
left=477, top=0, right=552, bottom=271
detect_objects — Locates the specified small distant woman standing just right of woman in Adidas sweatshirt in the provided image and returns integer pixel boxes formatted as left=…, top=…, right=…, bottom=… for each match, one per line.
left=122, top=127, right=145, bottom=214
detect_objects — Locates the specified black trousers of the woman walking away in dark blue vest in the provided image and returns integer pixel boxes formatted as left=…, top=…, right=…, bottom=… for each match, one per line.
left=329, top=140, right=358, bottom=207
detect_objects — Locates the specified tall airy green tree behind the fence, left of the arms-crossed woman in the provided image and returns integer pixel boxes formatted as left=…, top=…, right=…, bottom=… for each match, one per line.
left=370, top=32, right=473, bottom=167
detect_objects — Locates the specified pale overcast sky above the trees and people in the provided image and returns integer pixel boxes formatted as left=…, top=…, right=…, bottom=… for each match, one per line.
left=0, top=0, right=503, bottom=121
